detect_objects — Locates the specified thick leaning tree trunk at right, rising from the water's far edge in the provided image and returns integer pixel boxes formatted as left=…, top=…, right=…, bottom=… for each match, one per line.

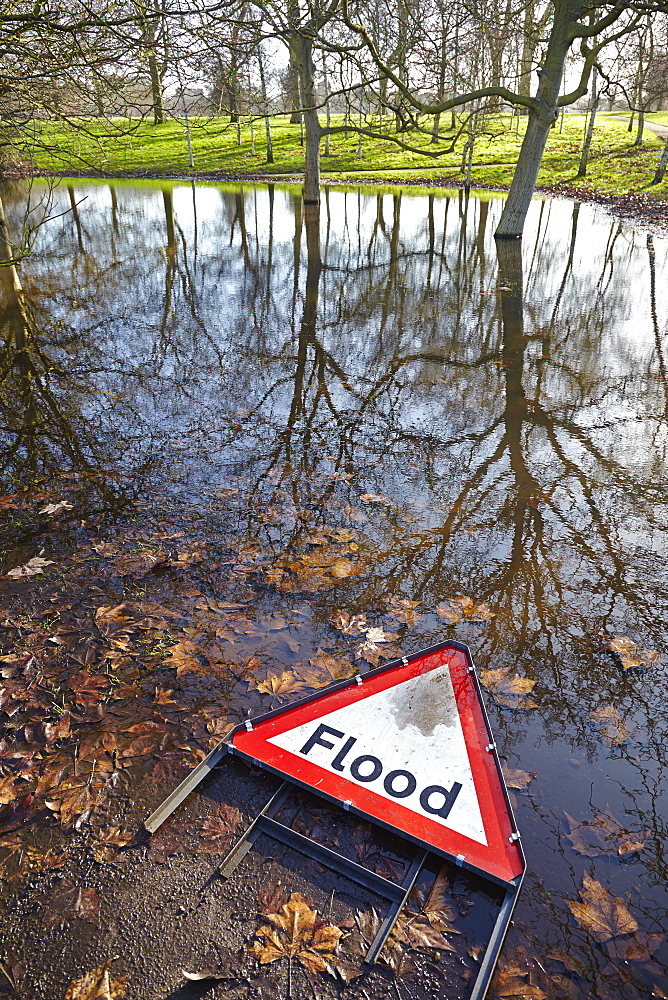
left=495, top=2, right=572, bottom=238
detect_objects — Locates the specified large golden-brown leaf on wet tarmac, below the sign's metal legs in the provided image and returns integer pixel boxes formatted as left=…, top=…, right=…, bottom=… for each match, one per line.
left=249, top=892, right=343, bottom=972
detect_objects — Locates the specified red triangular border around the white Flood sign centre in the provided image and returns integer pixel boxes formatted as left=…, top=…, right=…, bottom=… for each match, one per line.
left=228, top=643, right=524, bottom=882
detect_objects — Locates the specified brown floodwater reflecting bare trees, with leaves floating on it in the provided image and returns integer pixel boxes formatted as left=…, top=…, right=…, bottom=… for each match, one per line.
left=0, top=180, right=668, bottom=1000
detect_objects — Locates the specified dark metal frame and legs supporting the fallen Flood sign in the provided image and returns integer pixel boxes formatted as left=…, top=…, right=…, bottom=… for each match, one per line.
left=144, top=641, right=526, bottom=1000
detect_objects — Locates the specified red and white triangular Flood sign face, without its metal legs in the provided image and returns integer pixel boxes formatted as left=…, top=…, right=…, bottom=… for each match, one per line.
left=228, top=643, right=524, bottom=882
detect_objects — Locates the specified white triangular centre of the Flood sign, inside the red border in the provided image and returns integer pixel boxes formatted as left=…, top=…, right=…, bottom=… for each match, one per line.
left=267, top=665, right=487, bottom=846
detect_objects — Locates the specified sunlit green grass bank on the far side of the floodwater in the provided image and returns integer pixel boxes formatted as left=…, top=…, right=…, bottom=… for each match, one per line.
left=9, top=113, right=668, bottom=197
